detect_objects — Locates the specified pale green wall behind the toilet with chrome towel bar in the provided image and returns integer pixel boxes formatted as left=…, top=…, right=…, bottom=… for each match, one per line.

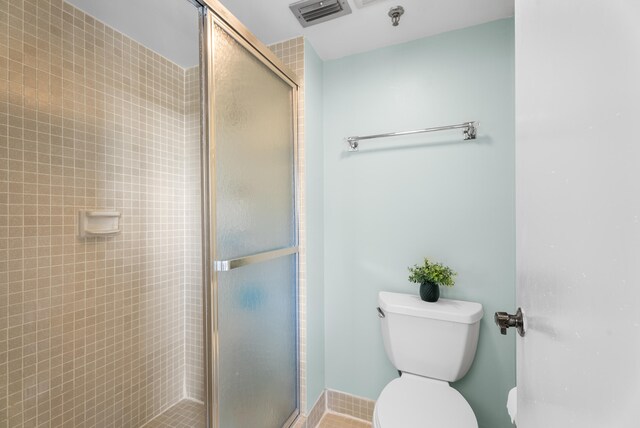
left=322, top=19, right=515, bottom=428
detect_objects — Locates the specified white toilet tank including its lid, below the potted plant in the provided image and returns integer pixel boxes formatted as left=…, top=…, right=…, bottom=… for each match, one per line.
left=378, top=291, right=483, bottom=382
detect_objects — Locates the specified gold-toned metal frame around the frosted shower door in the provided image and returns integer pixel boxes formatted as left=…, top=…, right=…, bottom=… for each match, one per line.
left=195, top=0, right=300, bottom=428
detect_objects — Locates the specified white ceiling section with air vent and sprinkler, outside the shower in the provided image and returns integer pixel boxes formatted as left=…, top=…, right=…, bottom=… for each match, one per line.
left=220, top=0, right=514, bottom=59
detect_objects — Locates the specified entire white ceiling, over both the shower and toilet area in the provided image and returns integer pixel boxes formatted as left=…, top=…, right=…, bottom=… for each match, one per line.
left=66, top=0, right=513, bottom=68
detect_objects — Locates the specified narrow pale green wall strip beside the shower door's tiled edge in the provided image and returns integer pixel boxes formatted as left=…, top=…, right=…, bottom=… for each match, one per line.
left=303, top=41, right=325, bottom=412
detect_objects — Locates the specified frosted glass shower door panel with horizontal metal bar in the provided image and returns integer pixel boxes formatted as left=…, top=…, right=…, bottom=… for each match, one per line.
left=209, top=18, right=298, bottom=428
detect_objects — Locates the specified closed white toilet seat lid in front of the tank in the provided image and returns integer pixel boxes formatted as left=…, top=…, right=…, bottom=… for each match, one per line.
left=374, top=373, right=478, bottom=428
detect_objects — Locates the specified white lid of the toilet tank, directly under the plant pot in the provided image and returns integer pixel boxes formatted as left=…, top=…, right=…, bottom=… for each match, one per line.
left=378, top=291, right=483, bottom=324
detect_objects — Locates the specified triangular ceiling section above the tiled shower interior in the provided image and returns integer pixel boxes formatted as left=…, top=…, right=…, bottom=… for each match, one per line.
left=65, top=0, right=199, bottom=68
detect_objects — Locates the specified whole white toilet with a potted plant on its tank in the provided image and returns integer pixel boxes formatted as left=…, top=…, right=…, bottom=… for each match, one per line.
left=373, top=292, right=483, bottom=428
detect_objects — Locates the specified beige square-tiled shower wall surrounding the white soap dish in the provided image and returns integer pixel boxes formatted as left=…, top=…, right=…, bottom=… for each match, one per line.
left=0, top=0, right=202, bottom=428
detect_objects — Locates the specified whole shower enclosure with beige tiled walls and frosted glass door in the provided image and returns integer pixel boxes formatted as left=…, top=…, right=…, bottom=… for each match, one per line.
left=0, top=0, right=299, bottom=428
